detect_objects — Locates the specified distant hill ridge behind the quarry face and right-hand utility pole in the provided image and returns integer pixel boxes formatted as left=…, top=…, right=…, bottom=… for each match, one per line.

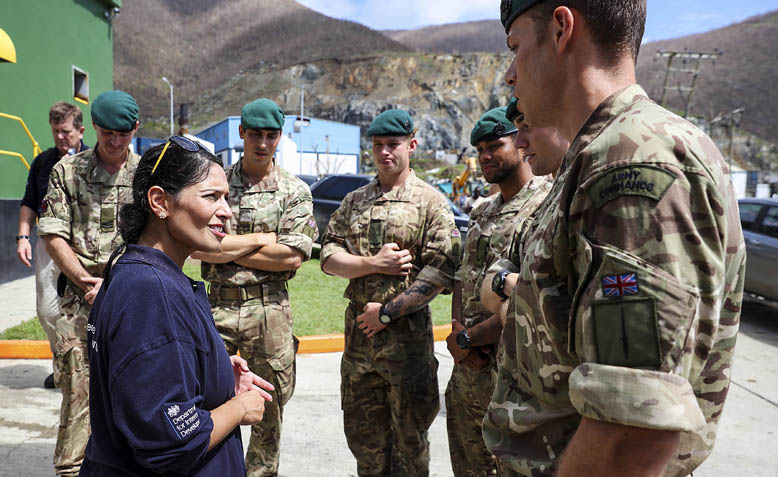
left=383, top=11, right=778, bottom=147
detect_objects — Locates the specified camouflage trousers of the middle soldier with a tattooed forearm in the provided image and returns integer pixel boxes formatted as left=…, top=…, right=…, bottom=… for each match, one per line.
left=341, top=305, right=440, bottom=477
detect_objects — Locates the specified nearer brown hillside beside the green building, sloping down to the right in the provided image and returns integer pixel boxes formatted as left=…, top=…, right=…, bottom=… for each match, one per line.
left=114, top=0, right=410, bottom=120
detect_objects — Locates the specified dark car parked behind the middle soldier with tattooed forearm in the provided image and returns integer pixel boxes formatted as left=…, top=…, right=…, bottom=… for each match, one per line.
left=311, top=174, right=470, bottom=242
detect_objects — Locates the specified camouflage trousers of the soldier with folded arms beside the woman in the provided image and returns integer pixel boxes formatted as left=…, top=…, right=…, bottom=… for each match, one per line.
left=211, top=284, right=296, bottom=477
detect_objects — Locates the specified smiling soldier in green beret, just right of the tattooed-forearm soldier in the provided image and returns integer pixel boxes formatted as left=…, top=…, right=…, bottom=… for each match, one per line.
left=446, top=107, right=551, bottom=477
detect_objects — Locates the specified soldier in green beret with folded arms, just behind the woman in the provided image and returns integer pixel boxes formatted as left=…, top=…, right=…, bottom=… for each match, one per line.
left=193, top=99, right=317, bottom=476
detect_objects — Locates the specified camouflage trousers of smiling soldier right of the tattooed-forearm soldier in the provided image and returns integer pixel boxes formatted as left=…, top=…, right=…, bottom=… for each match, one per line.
left=446, top=364, right=501, bottom=477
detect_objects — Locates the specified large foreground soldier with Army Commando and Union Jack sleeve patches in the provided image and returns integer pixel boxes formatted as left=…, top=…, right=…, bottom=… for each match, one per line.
left=482, top=0, right=745, bottom=476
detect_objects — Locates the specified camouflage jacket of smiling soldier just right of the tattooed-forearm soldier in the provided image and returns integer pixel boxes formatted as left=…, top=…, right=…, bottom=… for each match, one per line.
left=456, top=177, right=551, bottom=328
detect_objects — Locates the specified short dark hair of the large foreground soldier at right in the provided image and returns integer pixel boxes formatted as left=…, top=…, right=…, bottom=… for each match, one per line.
left=527, top=0, right=646, bottom=65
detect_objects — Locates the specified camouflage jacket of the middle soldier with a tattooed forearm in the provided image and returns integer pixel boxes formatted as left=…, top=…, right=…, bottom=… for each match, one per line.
left=321, top=171, right=460, bottom=303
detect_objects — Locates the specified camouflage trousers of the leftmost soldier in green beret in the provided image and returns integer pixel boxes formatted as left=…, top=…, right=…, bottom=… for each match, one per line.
left=54, top=286, right=92, bottom=476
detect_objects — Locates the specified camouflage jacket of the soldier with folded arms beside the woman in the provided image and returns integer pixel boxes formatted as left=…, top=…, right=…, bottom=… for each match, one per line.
left=202, top=159, right=317, bottom=287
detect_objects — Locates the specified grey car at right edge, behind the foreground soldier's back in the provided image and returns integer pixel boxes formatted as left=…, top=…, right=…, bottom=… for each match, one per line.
left=738, top=199, right=778, bottom=302
